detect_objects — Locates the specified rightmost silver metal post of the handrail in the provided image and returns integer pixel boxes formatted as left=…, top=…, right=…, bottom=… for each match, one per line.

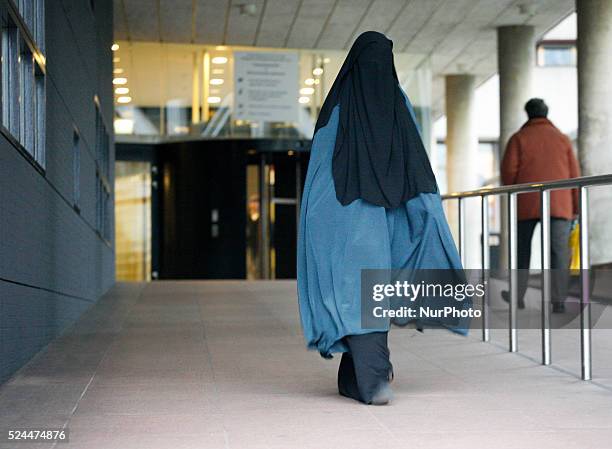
left=579, top=186, right=592, bottom=380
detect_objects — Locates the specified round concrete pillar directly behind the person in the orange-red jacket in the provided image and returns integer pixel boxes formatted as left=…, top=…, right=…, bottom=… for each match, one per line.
left=493, top=25, right=535, bottom=268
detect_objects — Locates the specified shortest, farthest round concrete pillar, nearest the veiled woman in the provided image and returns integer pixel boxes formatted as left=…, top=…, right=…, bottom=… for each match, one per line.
left=445, top=75, right=480, bottom=268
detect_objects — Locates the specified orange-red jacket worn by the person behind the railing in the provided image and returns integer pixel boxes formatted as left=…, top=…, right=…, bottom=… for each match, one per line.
left=501, top=118, right=580, bottom=220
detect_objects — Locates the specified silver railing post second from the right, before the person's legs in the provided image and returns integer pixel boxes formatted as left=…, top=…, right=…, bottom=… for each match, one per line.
left=540, top=190, right=551, bottom=365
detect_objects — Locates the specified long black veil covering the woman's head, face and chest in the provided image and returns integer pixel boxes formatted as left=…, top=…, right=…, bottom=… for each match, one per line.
left=315, top=31, right=438, bottom=208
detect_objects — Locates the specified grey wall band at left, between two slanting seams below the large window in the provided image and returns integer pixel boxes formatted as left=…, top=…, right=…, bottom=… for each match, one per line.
left=0, top=144, right=110, bottom=299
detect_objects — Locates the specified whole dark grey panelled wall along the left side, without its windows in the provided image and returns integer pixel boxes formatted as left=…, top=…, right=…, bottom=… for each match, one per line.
left=0, top=0, right=114, bottom=382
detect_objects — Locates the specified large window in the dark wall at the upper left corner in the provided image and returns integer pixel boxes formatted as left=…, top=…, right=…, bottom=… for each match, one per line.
left=0, top=0, right=45, bottom=168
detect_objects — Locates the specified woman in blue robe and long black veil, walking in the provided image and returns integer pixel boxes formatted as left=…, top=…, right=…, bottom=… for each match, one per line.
left=298, top=31, right=461, bottom=404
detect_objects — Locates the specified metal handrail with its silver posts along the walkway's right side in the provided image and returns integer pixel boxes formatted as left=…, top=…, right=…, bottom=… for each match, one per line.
left=442, top=174, right=612, bottom=380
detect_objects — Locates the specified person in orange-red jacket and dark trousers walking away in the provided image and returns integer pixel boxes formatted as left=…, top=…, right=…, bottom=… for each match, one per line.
left=501, top=98, right=580, bottom=313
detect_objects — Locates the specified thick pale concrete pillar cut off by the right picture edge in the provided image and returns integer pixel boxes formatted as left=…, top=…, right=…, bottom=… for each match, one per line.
left=576, top=0, right=612, bottom=265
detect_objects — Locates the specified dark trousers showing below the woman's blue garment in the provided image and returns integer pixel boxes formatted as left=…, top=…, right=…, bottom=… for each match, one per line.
left=338, top=332, right=392, bottom=404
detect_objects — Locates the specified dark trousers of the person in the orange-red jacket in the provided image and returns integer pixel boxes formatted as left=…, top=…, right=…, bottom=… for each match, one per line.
left=517, top=217, right=572, bottom=303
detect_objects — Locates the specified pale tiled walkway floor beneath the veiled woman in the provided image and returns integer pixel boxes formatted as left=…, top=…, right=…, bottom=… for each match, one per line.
left=0, top=281, right=612, bottom=449
